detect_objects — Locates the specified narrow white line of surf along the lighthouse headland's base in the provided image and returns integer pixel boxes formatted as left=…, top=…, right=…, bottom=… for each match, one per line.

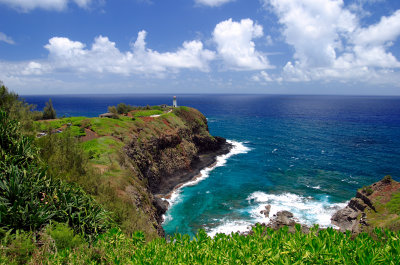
left=163, top=140, right=251, bottom=223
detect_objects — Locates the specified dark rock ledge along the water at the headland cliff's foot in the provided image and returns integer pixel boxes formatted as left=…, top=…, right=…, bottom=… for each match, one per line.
left=155, top=141, right=233, bottom=196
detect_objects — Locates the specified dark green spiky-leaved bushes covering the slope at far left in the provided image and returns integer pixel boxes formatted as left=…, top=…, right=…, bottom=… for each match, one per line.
left=0, top=111, right=110, bottom=237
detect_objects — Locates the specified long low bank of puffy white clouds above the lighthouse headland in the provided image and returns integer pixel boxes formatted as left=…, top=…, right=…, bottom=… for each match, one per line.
left=40, top=31, right=215, bottom=75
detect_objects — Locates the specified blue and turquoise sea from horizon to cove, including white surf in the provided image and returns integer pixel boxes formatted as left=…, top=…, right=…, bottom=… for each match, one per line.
left=24, top=95, right=400, bottom=235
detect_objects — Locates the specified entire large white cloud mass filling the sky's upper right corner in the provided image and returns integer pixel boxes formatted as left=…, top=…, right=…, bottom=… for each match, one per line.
left=264, top=0, right=400, bottom=81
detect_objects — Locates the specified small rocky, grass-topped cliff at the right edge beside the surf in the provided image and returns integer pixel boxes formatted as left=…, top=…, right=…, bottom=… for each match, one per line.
left=331, top=176, right=400, bottom=234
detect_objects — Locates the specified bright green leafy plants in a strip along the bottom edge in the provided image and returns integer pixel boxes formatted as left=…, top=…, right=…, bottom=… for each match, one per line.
left=0, top=225, right=400, bottom=264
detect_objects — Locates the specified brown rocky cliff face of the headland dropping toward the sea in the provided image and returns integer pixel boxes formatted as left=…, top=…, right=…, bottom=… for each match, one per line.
left=123, top=107, right=231, bottom=235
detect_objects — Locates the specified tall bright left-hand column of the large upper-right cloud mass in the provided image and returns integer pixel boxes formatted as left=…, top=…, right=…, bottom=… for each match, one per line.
left=267, top=0, right=356, bottom=67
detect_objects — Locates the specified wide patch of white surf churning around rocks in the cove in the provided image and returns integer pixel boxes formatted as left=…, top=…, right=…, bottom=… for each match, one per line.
left=206, top=191, right=347, bottom=237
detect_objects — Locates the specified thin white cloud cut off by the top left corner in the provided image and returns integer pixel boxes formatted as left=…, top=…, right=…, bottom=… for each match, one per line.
left=0, top=0, right=93, bottom=12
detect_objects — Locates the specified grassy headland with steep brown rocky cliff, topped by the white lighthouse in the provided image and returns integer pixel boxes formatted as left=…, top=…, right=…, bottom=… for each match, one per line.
left=38, top=107, right=229, bottom=239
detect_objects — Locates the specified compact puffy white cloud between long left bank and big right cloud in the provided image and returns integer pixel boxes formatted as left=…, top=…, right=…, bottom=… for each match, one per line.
left=213, top=19, right=272, bottom=70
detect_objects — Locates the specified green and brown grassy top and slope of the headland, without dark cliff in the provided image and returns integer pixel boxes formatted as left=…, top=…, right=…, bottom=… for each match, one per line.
left=36, top=104, right=211, bottom=240
